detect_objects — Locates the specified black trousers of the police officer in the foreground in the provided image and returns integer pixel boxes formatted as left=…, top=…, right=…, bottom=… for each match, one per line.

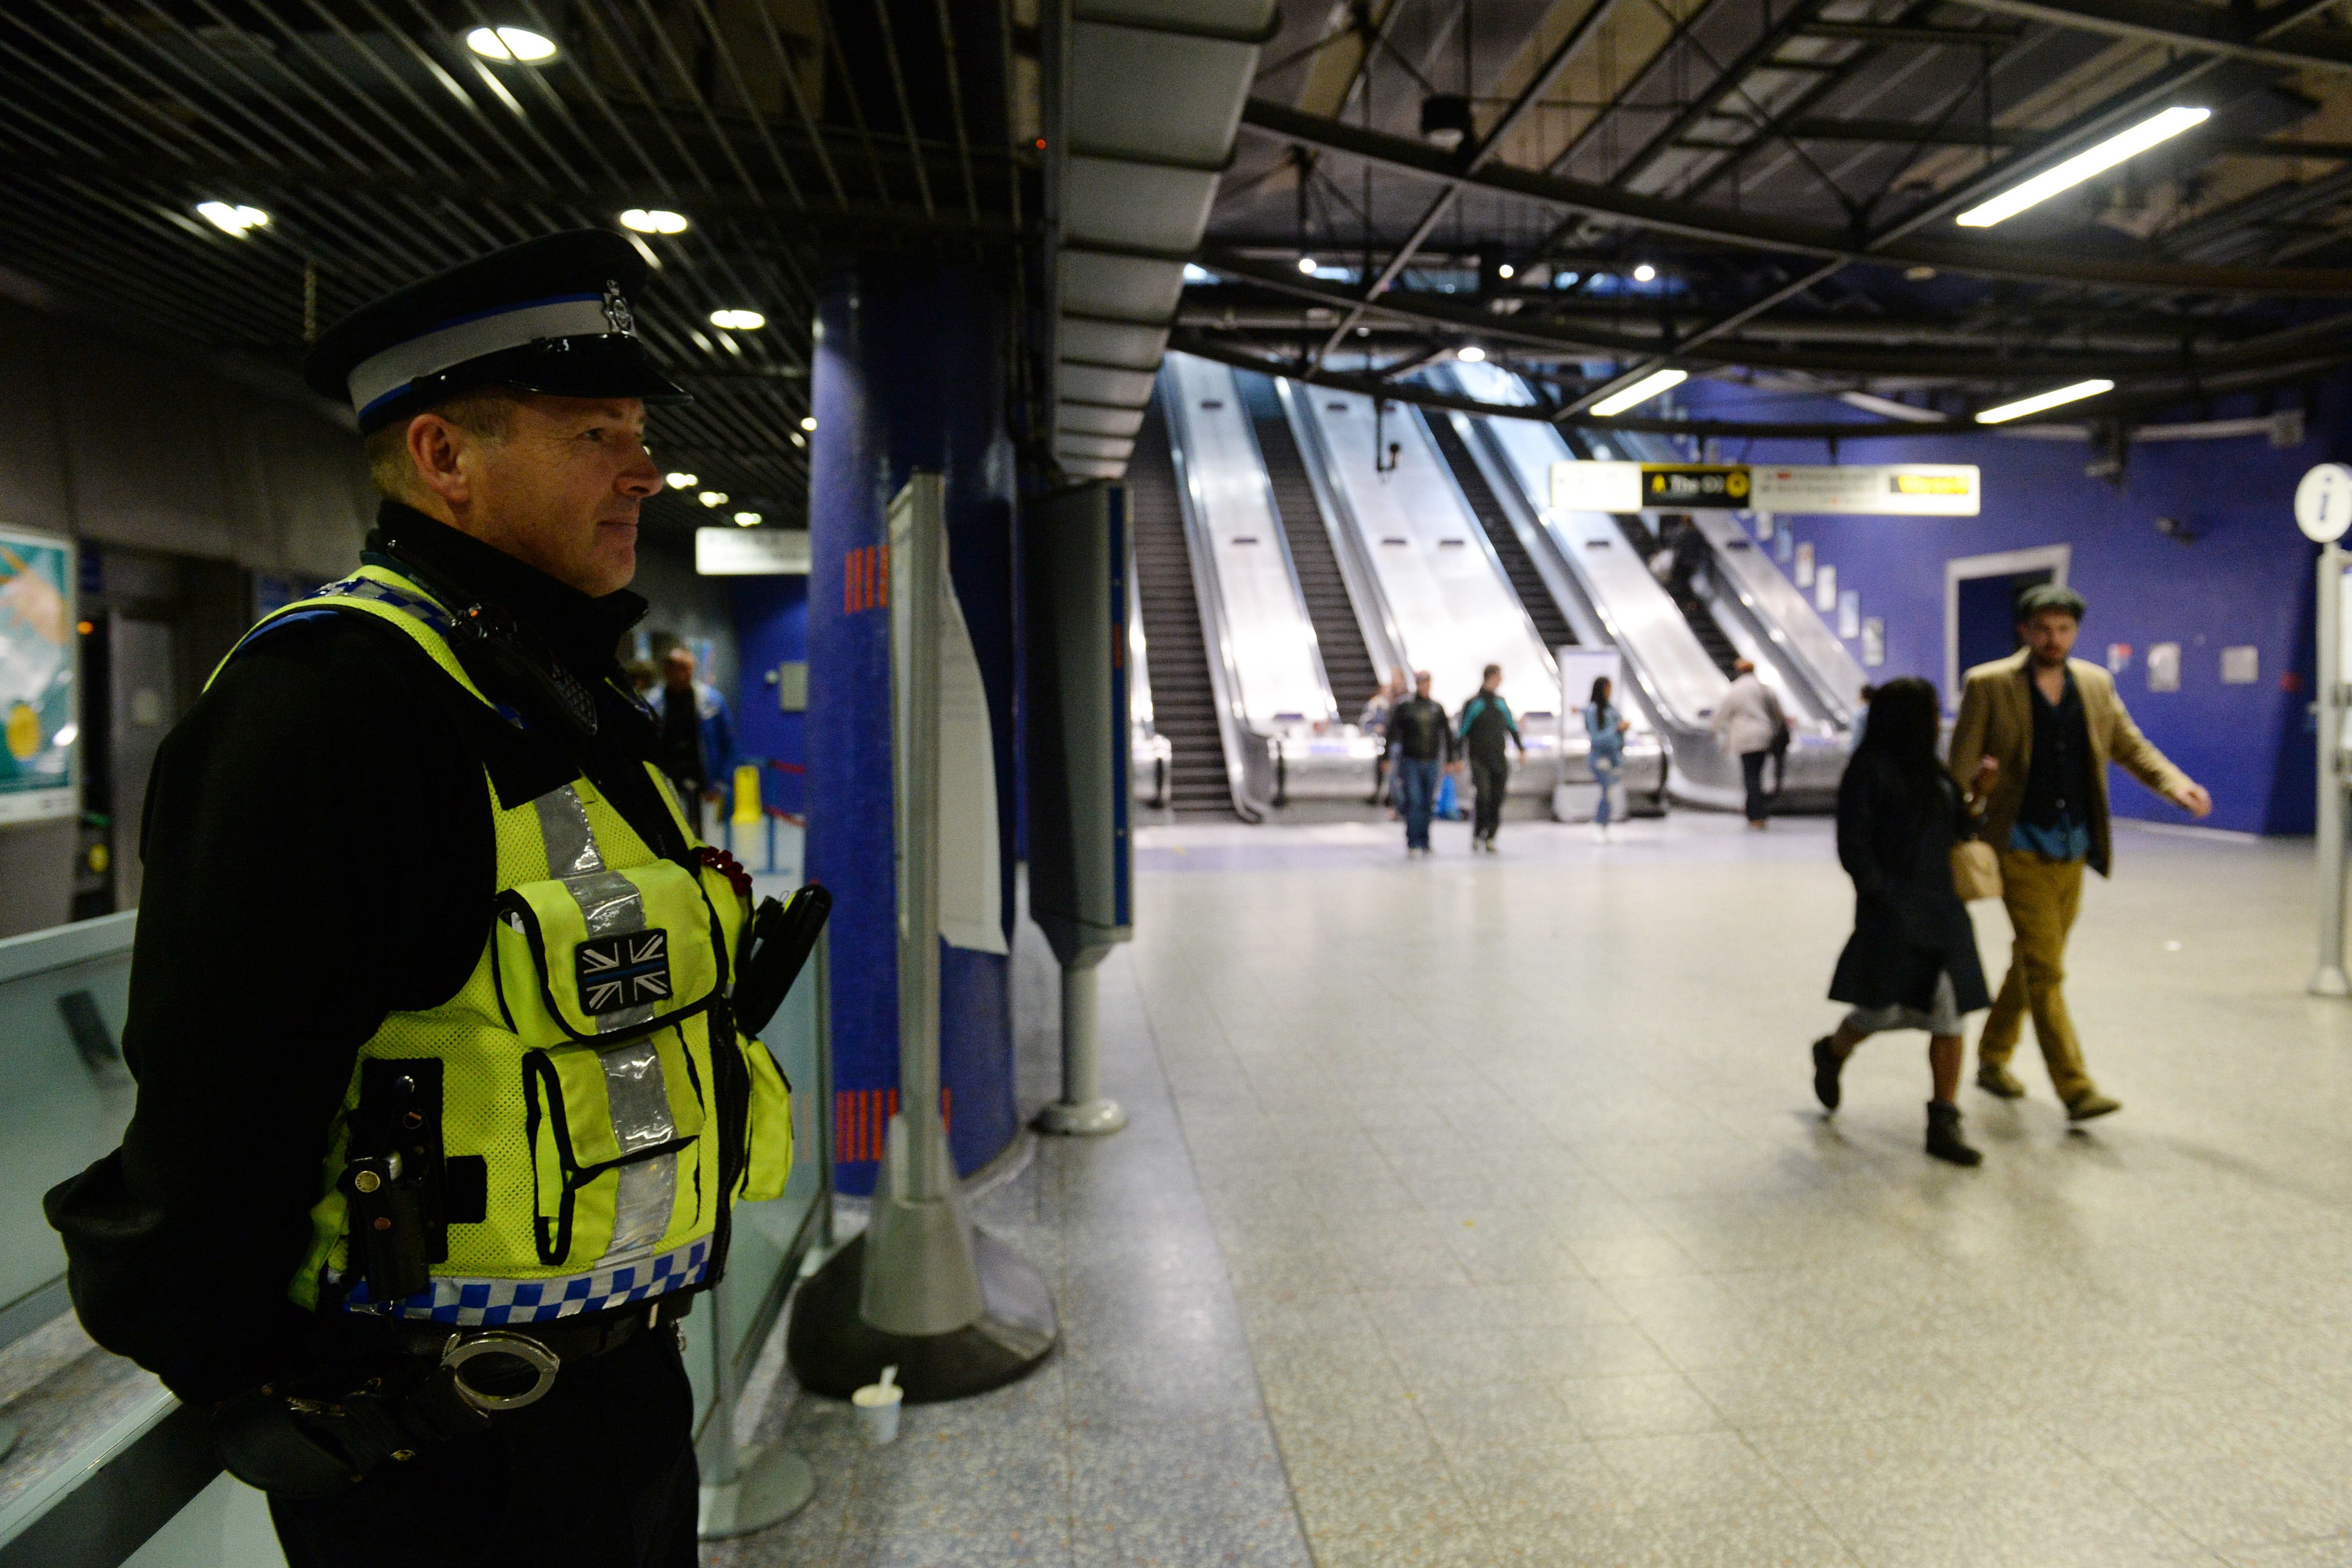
left=270, top=1326, right=696, bottom=1568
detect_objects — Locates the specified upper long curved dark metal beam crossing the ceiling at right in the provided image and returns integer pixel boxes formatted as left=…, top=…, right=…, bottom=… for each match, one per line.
left=1242, top=99, right=2352, bottom=294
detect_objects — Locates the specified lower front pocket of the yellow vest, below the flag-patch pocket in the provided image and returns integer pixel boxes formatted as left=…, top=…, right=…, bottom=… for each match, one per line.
left=522, top=1025, right=708, bottom=1267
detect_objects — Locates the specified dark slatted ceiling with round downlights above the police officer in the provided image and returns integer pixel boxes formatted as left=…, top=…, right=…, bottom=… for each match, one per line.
left=0, top=0, right=1023, bottom=531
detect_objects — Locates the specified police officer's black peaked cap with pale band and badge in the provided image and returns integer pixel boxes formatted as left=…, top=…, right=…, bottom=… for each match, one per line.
left=304, top=228, right=692, bottom=435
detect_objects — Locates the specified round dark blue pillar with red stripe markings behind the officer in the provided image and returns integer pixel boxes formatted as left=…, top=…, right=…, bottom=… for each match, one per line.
left=804, top=266, right=1018, bottom=1194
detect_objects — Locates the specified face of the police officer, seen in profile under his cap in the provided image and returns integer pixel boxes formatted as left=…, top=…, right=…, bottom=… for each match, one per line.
left=412, top=393, right=661, bottom=595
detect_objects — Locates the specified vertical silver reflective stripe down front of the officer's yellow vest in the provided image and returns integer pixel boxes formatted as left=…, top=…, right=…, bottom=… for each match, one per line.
left=531, top=785, right=677, bottom=1262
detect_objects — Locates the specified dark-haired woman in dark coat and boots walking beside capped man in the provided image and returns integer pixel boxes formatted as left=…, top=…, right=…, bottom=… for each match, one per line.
left=1813, top=677, right=1992, bottom=1166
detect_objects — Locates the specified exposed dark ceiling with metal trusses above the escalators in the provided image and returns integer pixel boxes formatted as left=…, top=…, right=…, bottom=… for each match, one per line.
left=1183, top=0, right=2352, bottom=432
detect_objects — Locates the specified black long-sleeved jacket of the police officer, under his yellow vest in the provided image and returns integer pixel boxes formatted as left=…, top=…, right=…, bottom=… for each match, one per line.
left=47, top=501, right=687, bottom=1404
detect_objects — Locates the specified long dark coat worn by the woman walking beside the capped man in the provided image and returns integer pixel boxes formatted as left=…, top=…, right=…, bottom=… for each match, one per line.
left=1830, top=750, right=1992, bottom=1013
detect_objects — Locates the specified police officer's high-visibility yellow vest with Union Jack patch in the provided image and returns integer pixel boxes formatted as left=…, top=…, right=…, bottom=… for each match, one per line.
left=214, top=564, right=793, bottom=1326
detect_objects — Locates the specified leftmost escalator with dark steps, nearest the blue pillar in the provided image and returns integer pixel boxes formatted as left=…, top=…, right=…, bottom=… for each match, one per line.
left=1127, top=400, right=1232, bottom=811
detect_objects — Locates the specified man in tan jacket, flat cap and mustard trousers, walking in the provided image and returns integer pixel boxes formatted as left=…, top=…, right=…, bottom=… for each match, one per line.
left=1950, top=583, right=2213, bottom=1121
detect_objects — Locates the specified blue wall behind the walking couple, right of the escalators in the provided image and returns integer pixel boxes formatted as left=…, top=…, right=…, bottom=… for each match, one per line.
left=1688, top=385, right=2323, bottom=832
